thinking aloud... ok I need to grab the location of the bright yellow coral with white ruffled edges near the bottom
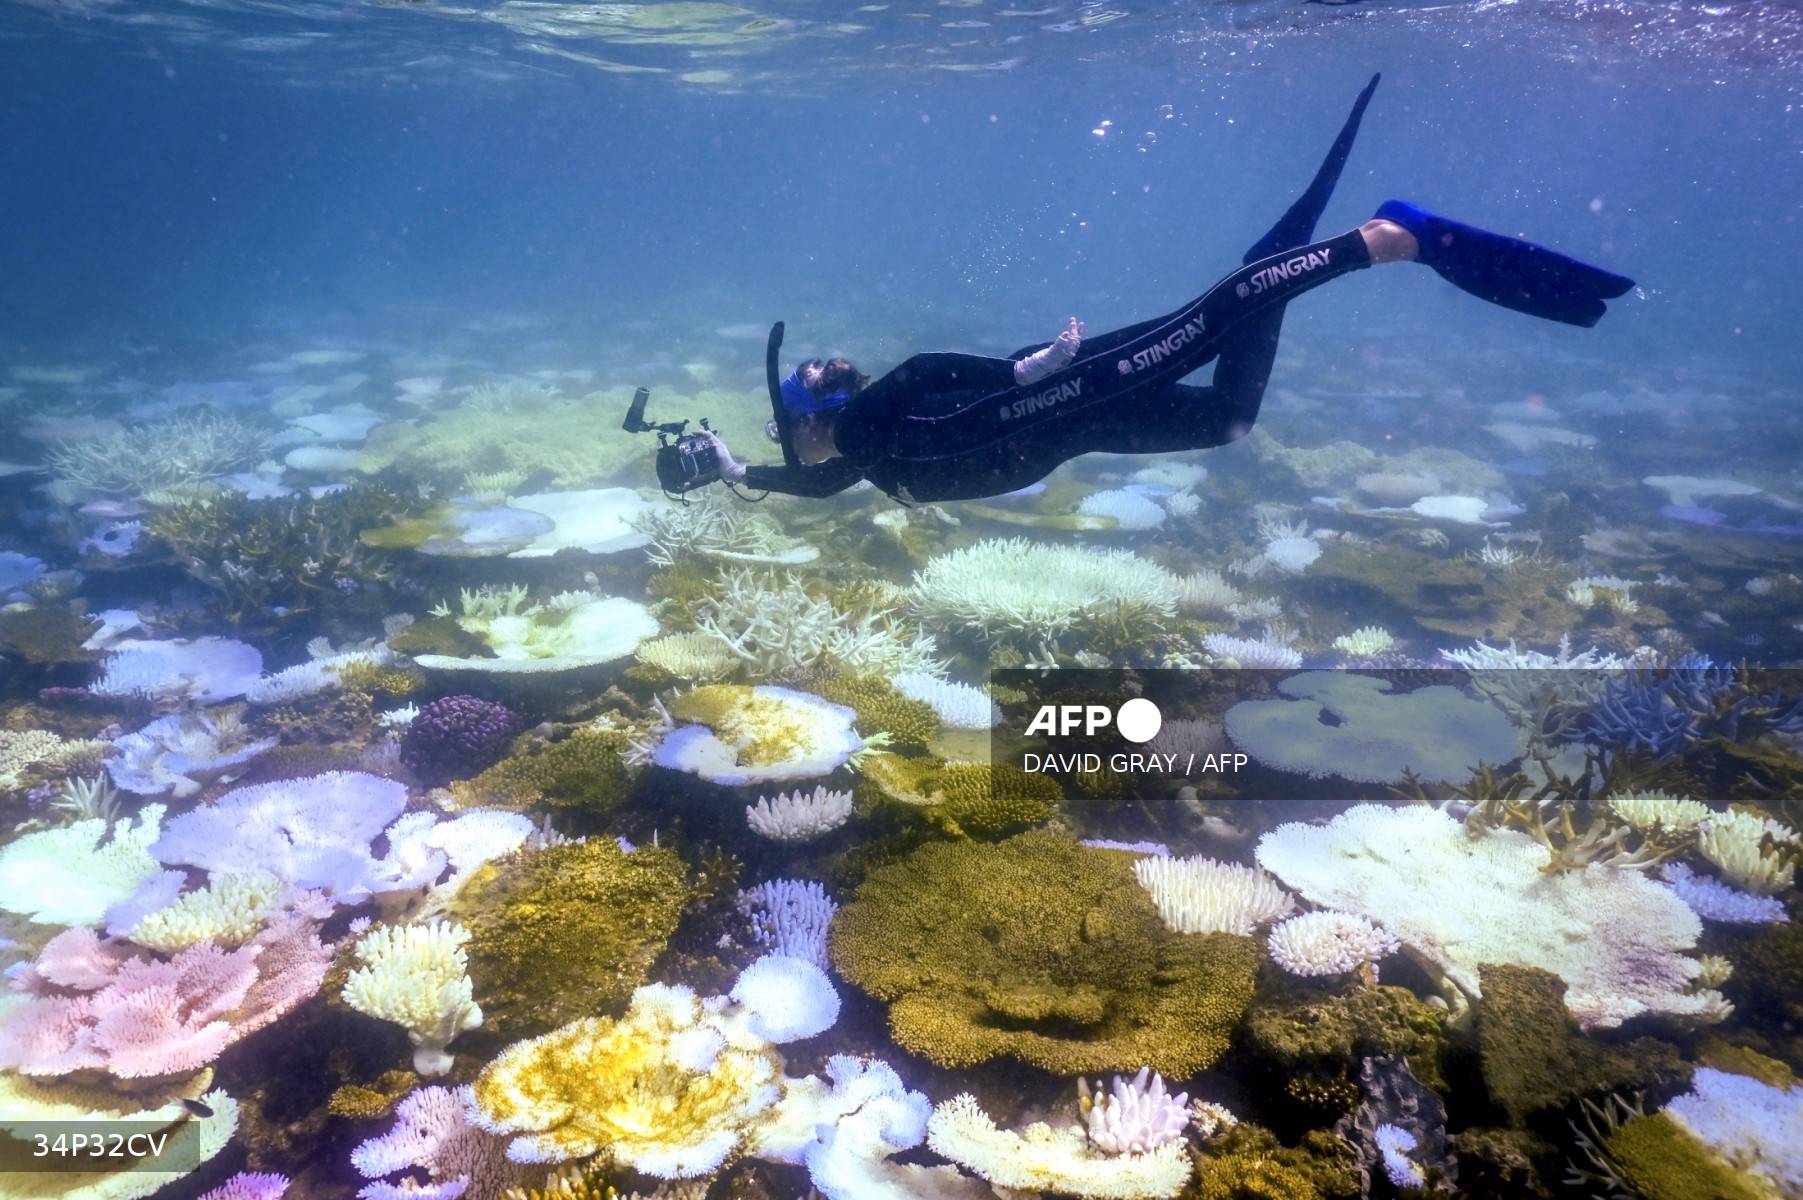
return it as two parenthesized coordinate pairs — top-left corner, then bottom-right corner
(472, 986), (783, 1177)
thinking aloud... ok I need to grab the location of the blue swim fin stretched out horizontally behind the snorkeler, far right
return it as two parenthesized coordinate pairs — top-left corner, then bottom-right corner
(1377, 200), (1634, 326)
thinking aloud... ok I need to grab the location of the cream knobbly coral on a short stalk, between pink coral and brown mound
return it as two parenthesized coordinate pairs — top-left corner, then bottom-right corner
(344, 921), (481, 1076)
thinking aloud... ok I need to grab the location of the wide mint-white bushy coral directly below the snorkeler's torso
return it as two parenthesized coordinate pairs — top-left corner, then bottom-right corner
(914, 537), (1177, 638)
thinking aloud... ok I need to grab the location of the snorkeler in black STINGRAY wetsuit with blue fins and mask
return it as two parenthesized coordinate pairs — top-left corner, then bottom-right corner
(709, 76), (1634, 503)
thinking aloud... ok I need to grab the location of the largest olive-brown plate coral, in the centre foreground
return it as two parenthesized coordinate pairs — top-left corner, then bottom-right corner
(829, 831), (1260, 1079)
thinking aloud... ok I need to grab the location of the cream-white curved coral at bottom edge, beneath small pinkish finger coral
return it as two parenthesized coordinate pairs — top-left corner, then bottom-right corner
(927, 1092), (1190, 1200)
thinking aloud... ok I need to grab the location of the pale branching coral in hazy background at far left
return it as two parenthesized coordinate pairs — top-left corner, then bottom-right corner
(50, 409), (269, 495)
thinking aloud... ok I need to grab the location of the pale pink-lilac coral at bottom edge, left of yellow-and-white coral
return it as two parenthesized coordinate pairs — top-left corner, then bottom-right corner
(350, 1086), (526, 1200)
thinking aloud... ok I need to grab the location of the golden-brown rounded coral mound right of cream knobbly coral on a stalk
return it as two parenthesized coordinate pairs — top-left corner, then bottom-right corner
(451, 838), (689, 1036)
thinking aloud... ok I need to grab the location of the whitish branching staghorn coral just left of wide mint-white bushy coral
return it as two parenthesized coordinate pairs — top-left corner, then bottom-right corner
(696, 568), (945, 676)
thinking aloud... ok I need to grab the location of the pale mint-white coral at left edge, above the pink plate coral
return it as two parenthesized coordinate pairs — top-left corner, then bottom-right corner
(0, 804), (164, 926)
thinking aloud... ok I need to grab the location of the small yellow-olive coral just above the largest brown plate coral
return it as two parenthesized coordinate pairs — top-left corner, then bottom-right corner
(860, 755), (1064, 838)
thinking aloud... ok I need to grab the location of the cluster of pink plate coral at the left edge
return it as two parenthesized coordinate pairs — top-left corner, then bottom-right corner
(0, 914), (332, 1079)
